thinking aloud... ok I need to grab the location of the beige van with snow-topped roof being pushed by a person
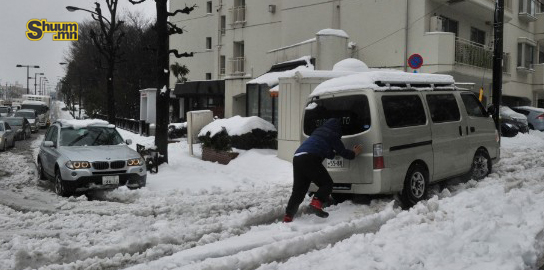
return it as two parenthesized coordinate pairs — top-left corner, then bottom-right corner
(302, 71), (500, 206)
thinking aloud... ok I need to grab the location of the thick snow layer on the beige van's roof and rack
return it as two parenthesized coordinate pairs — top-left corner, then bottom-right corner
(310, 70), (457, 97)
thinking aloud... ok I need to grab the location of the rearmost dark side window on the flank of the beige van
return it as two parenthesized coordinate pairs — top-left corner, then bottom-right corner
(382, 95), (427, 128)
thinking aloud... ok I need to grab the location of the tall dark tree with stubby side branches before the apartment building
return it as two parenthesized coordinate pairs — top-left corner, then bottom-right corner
(129, 0), (197, 162)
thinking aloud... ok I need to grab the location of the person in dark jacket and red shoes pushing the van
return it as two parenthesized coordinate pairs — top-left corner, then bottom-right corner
(283, 118), (363, 223)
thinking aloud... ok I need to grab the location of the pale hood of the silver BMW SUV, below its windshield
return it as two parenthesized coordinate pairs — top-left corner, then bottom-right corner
(58, 145), (140, 162)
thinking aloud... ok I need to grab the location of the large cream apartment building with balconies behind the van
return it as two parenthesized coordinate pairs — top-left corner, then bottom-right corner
(170, 0), (544, 118)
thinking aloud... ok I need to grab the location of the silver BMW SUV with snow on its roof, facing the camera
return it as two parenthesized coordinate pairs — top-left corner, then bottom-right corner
(37, 120), (147, 196)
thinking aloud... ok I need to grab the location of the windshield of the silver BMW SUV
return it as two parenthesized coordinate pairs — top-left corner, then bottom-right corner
(60, 126), (123, 146)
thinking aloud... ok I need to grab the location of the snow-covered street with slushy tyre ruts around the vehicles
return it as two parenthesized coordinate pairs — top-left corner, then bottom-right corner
(0, 103), (544, 270)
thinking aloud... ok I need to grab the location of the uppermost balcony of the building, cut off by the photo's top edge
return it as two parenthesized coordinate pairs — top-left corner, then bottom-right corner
(433, 0), (512, 22)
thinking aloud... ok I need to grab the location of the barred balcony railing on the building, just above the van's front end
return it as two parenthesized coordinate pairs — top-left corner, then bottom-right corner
(455, 38), (510, 73)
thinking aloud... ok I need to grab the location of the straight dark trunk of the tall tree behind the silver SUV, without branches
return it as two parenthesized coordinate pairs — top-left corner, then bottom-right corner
(155, 0), (170, 162)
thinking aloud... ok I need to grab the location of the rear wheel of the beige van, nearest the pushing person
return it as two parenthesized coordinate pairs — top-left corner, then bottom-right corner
(401, 164), (429, 207)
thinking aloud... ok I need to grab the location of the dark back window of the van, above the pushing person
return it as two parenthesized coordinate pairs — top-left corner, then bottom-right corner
(304, 95), (370, 135)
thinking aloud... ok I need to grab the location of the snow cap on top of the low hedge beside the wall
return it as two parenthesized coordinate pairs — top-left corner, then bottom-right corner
(198, 115), (276, 137)
